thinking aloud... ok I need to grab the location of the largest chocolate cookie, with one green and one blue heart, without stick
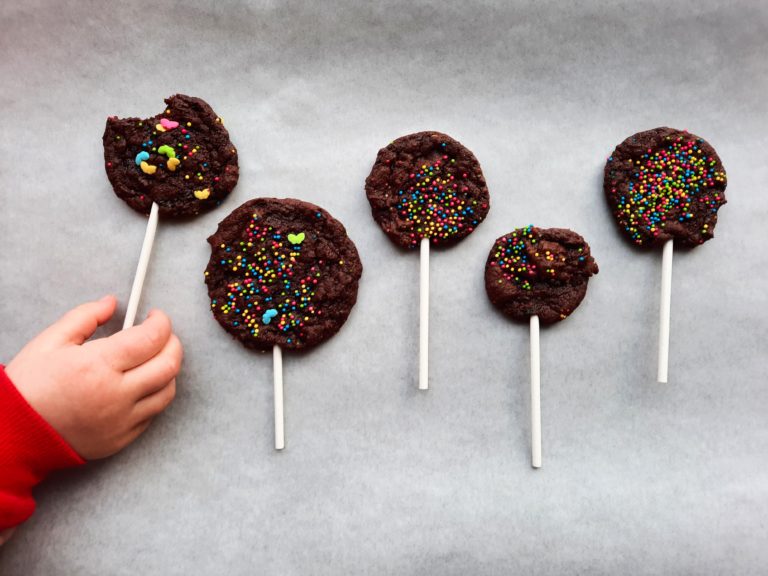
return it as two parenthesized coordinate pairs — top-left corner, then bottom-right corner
(205, 198), (363, 350)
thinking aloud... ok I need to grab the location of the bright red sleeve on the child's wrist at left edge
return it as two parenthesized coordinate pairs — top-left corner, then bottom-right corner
(0, 365), (85, 530)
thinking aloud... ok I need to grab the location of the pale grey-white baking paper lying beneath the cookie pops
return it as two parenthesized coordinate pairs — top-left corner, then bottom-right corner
(0, 0), (768, 576)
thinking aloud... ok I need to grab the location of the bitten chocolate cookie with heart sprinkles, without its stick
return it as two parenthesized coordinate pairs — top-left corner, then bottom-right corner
(104, 94), (238, 216)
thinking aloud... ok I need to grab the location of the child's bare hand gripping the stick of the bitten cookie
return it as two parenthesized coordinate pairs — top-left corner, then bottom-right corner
(5, 296), (182, 460)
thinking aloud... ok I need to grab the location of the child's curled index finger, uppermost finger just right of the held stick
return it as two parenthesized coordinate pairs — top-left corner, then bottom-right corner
(94, 310), (171, 371)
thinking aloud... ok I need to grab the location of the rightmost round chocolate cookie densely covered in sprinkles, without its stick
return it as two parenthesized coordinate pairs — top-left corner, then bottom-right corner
(603, 128), (727, 247)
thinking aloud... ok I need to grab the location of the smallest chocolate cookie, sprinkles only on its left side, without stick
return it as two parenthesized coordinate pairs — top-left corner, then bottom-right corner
(485, 226), (598, 324)
